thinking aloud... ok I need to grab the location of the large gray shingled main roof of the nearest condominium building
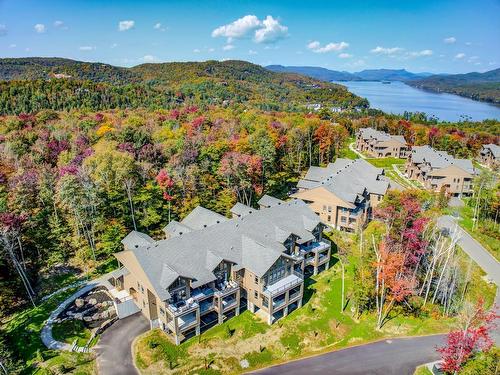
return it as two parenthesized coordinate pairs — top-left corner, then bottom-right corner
(120, 200), (324, 300)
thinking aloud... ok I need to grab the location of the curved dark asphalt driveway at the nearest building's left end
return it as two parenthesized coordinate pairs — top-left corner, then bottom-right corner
(95, 313), (149, 375)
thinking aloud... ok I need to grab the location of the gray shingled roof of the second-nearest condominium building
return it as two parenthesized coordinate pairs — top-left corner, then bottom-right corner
(297, 158), (389, 204)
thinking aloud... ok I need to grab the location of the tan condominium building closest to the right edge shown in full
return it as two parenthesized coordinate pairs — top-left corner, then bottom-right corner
(406, 146), (476, 196)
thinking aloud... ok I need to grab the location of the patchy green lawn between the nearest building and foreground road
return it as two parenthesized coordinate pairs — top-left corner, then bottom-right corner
(134, 232), (495, 374)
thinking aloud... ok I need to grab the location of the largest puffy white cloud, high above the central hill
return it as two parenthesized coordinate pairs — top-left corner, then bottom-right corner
(212, 14), (288, 43)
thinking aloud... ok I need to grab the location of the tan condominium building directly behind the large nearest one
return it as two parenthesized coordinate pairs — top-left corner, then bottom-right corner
(292, 158), (401, 232)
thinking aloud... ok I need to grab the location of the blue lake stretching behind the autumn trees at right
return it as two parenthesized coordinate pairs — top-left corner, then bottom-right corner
(336, 81), (500, 121)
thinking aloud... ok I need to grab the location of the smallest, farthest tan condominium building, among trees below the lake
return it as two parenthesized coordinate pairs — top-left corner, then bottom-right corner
(356, 128), (409, 158)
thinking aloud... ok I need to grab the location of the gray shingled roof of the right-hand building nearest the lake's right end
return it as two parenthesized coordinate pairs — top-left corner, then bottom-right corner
(411, 145), (475, 174)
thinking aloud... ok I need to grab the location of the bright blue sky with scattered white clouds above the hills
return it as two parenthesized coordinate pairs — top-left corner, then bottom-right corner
(0, 0), (500, 73)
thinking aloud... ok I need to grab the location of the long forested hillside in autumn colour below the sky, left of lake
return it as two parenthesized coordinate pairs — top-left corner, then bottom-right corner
(0, 58), (368, 114)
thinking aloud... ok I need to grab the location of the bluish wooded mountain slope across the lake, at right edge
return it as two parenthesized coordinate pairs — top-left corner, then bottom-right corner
(406, 69), (500, 104)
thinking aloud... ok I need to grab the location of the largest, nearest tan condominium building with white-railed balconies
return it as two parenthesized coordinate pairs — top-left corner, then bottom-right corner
(110, 196), (331, 344)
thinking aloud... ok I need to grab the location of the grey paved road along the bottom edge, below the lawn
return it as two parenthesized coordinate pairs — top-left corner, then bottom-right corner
(255, 335), (444, 375)
